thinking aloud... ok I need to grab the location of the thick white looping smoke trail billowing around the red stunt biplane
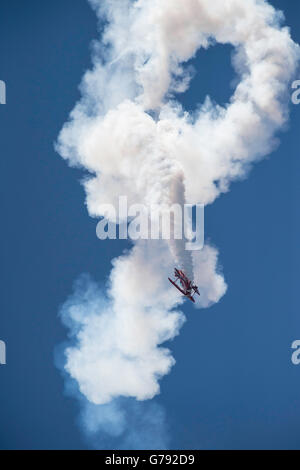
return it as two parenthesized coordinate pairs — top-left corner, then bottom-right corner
(57, 0), (299, 447)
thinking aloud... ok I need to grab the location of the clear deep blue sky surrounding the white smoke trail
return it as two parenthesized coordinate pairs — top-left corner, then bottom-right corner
(0, 0), (300, 449)
